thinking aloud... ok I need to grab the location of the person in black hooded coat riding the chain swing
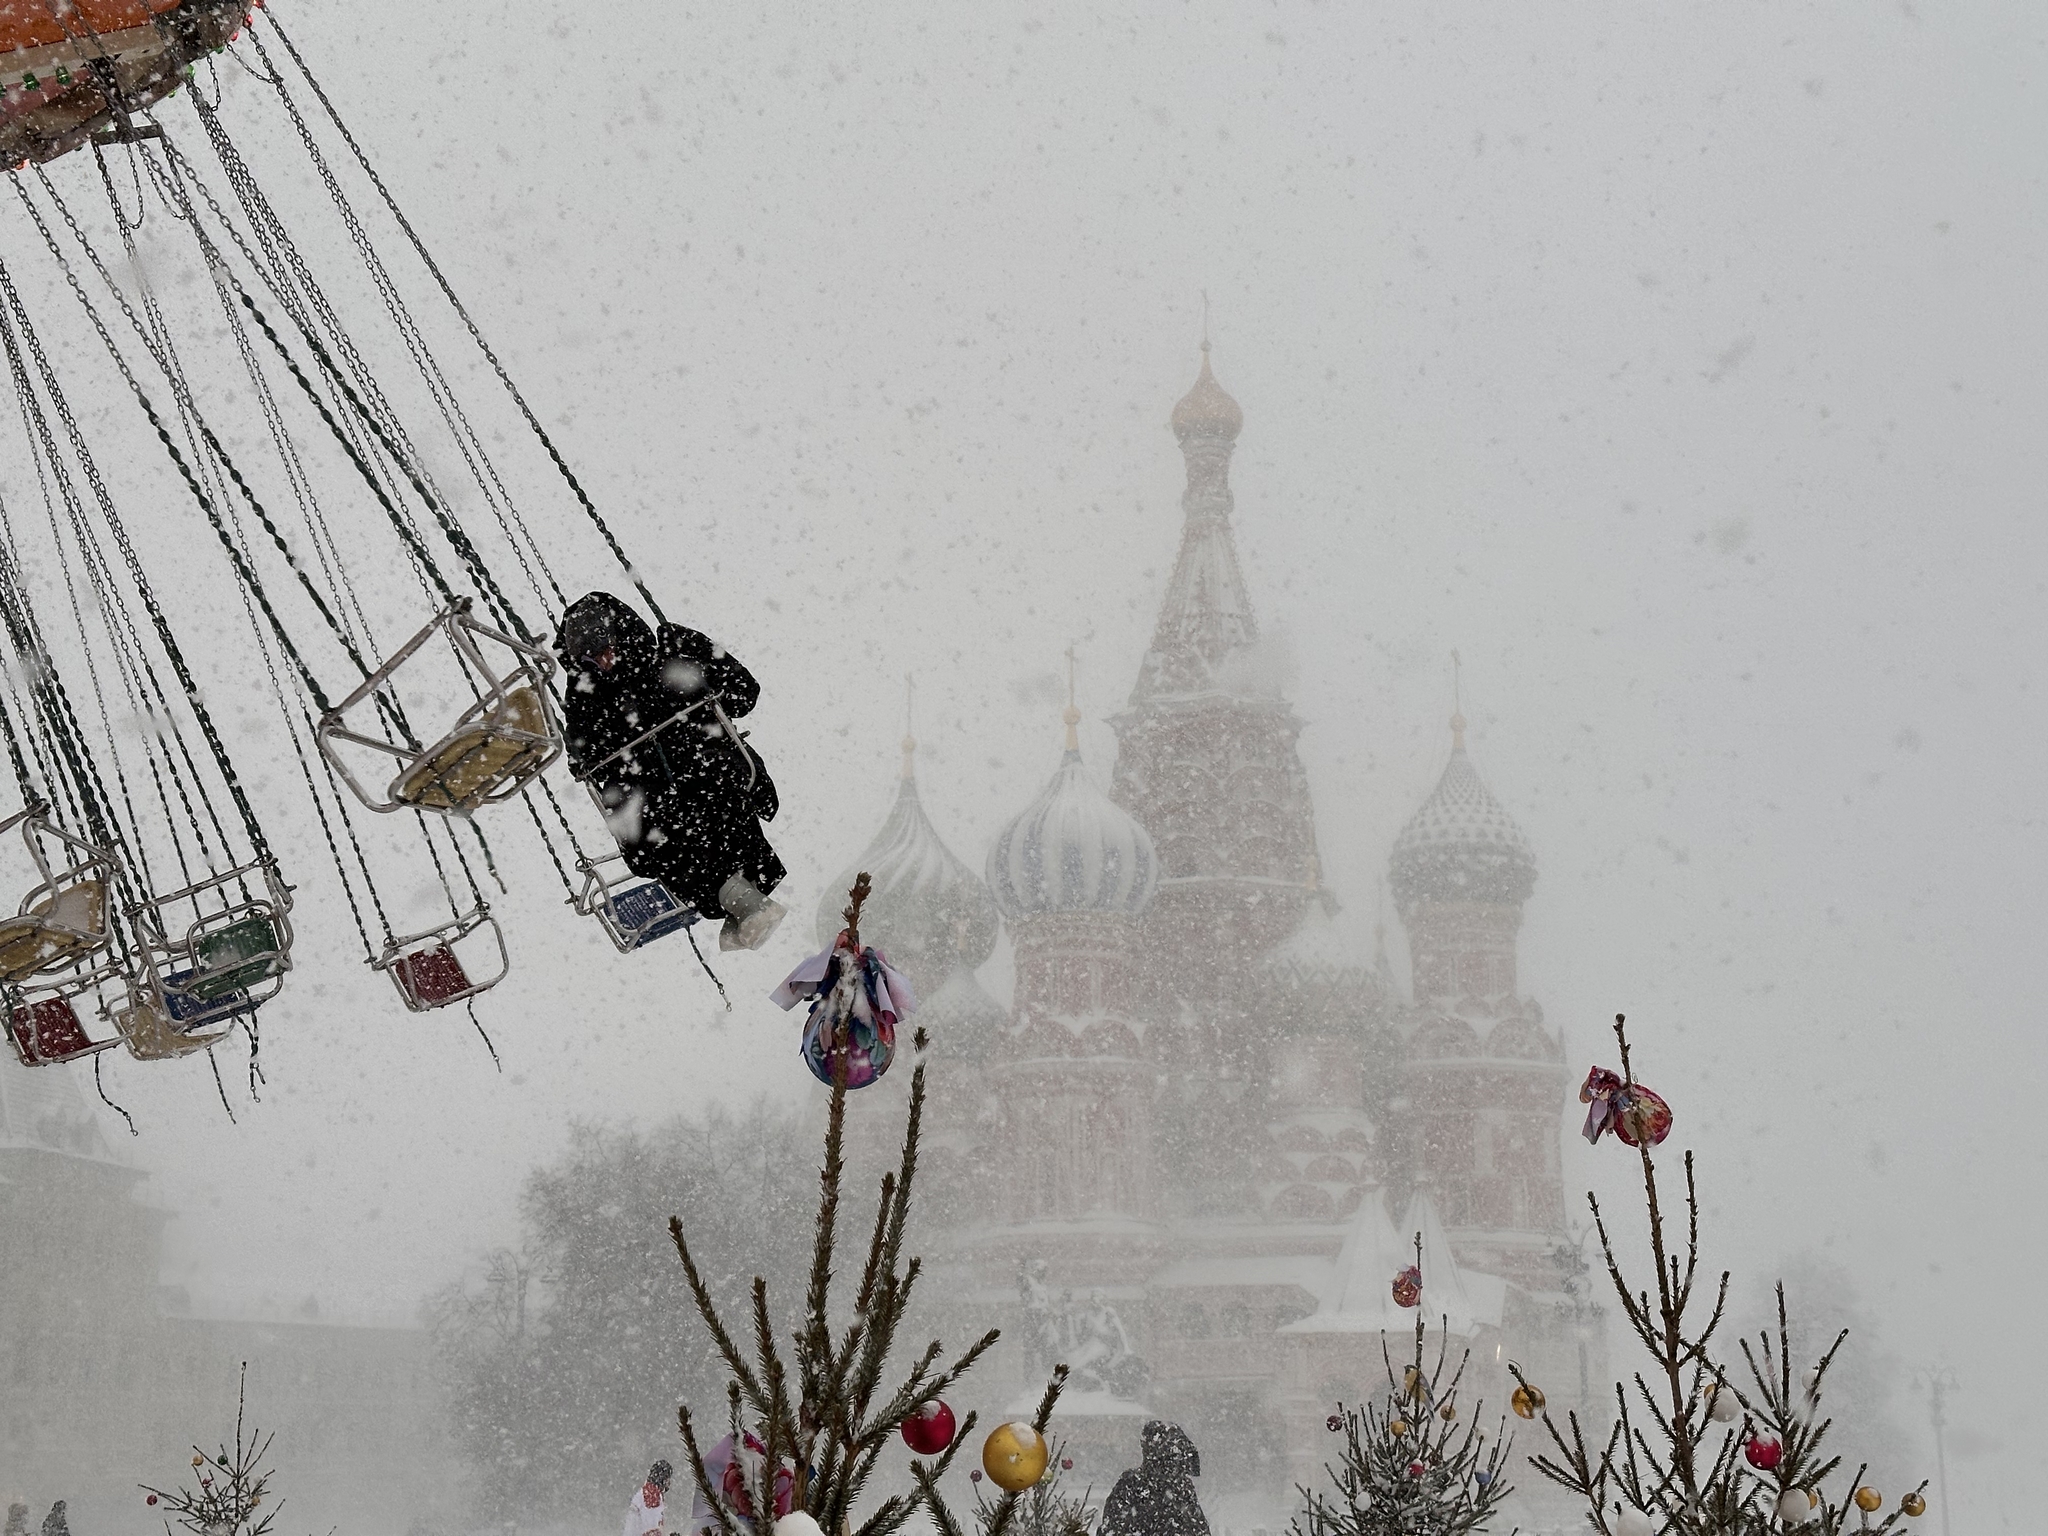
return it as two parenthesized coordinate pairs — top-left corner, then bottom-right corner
(559, 592), (784, 948)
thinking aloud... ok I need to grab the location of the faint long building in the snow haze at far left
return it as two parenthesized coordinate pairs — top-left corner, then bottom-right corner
(0, 1063), (457, 1534)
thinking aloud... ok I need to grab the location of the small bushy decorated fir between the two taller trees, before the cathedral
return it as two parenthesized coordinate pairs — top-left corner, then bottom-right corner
(1290, 1233), (1513, 1536)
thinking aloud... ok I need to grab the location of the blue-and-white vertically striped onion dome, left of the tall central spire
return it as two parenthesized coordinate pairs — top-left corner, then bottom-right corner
(987, 707), (1159, 920)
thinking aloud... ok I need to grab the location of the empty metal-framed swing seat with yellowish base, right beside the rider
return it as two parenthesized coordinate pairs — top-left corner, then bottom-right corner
(313, 598), (561, 817)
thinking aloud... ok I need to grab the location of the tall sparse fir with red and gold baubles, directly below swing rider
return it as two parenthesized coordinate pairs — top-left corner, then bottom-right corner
(670, 872), (1067, 1536)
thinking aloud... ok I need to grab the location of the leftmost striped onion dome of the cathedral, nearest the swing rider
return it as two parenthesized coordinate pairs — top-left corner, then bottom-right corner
(817, 737), (995, 989)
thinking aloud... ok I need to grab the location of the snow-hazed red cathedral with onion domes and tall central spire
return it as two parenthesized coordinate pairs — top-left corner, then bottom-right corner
(817, 352), (1591, 1526)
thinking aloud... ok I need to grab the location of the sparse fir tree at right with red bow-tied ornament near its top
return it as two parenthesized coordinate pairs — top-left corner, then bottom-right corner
(1507, 1014), (1927, 1536)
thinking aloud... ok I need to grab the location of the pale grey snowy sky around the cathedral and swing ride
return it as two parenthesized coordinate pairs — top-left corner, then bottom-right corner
(8, 0), (2048, 1532)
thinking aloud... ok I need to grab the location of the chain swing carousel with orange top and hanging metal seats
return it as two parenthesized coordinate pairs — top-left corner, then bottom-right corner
(0, 0), (780, 1097)
